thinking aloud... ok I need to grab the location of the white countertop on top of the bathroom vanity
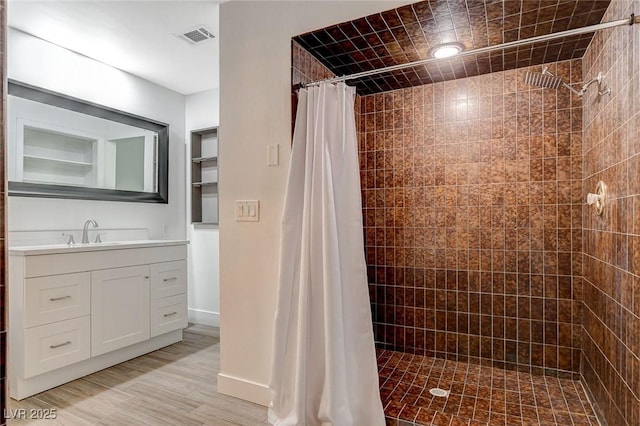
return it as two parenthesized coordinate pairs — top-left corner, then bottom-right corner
(9, 240), (189, 256)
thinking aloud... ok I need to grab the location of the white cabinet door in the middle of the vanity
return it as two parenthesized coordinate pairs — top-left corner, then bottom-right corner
(91, 266), (149, 356)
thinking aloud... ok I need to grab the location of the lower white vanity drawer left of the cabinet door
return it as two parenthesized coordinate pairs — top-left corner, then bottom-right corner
(24, 316), (91, 378)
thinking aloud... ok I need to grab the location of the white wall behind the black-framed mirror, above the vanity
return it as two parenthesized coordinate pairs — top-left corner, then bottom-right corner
(7, 29), (186, 239)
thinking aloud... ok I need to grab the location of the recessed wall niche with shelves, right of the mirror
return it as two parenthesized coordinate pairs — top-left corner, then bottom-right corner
(191, 127), (218, 225)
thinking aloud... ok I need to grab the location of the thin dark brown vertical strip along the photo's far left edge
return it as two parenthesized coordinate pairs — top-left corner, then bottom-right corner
(0, 0), (8, 425)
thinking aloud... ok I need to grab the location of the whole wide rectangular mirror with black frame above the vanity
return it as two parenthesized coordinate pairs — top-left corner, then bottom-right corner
(7, 80), (169, 203)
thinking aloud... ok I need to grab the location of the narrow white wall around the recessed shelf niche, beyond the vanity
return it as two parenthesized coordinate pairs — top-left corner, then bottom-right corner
(185, 89), (224, 326)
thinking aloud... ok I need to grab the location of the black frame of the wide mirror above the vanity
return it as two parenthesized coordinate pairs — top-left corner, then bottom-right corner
(7, 79), (169, 204)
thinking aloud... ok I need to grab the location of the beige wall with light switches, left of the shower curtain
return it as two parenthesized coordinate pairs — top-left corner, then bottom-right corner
(218, 1), (410, 405)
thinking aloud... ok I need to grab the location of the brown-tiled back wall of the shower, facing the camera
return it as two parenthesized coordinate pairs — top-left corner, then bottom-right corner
(360, 60), (582, 374)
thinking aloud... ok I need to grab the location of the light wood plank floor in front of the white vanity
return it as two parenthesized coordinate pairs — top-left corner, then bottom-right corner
(9, 325), (268, 426)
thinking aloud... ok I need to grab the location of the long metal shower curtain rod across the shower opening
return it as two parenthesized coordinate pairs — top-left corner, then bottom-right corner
(301, 13), (640, 87)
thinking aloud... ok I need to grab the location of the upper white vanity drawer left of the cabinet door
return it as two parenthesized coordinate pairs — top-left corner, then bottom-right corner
(24, 272), (91, 328)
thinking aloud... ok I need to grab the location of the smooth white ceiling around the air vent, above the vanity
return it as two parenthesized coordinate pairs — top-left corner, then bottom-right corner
(8, 0), (219, 95)
